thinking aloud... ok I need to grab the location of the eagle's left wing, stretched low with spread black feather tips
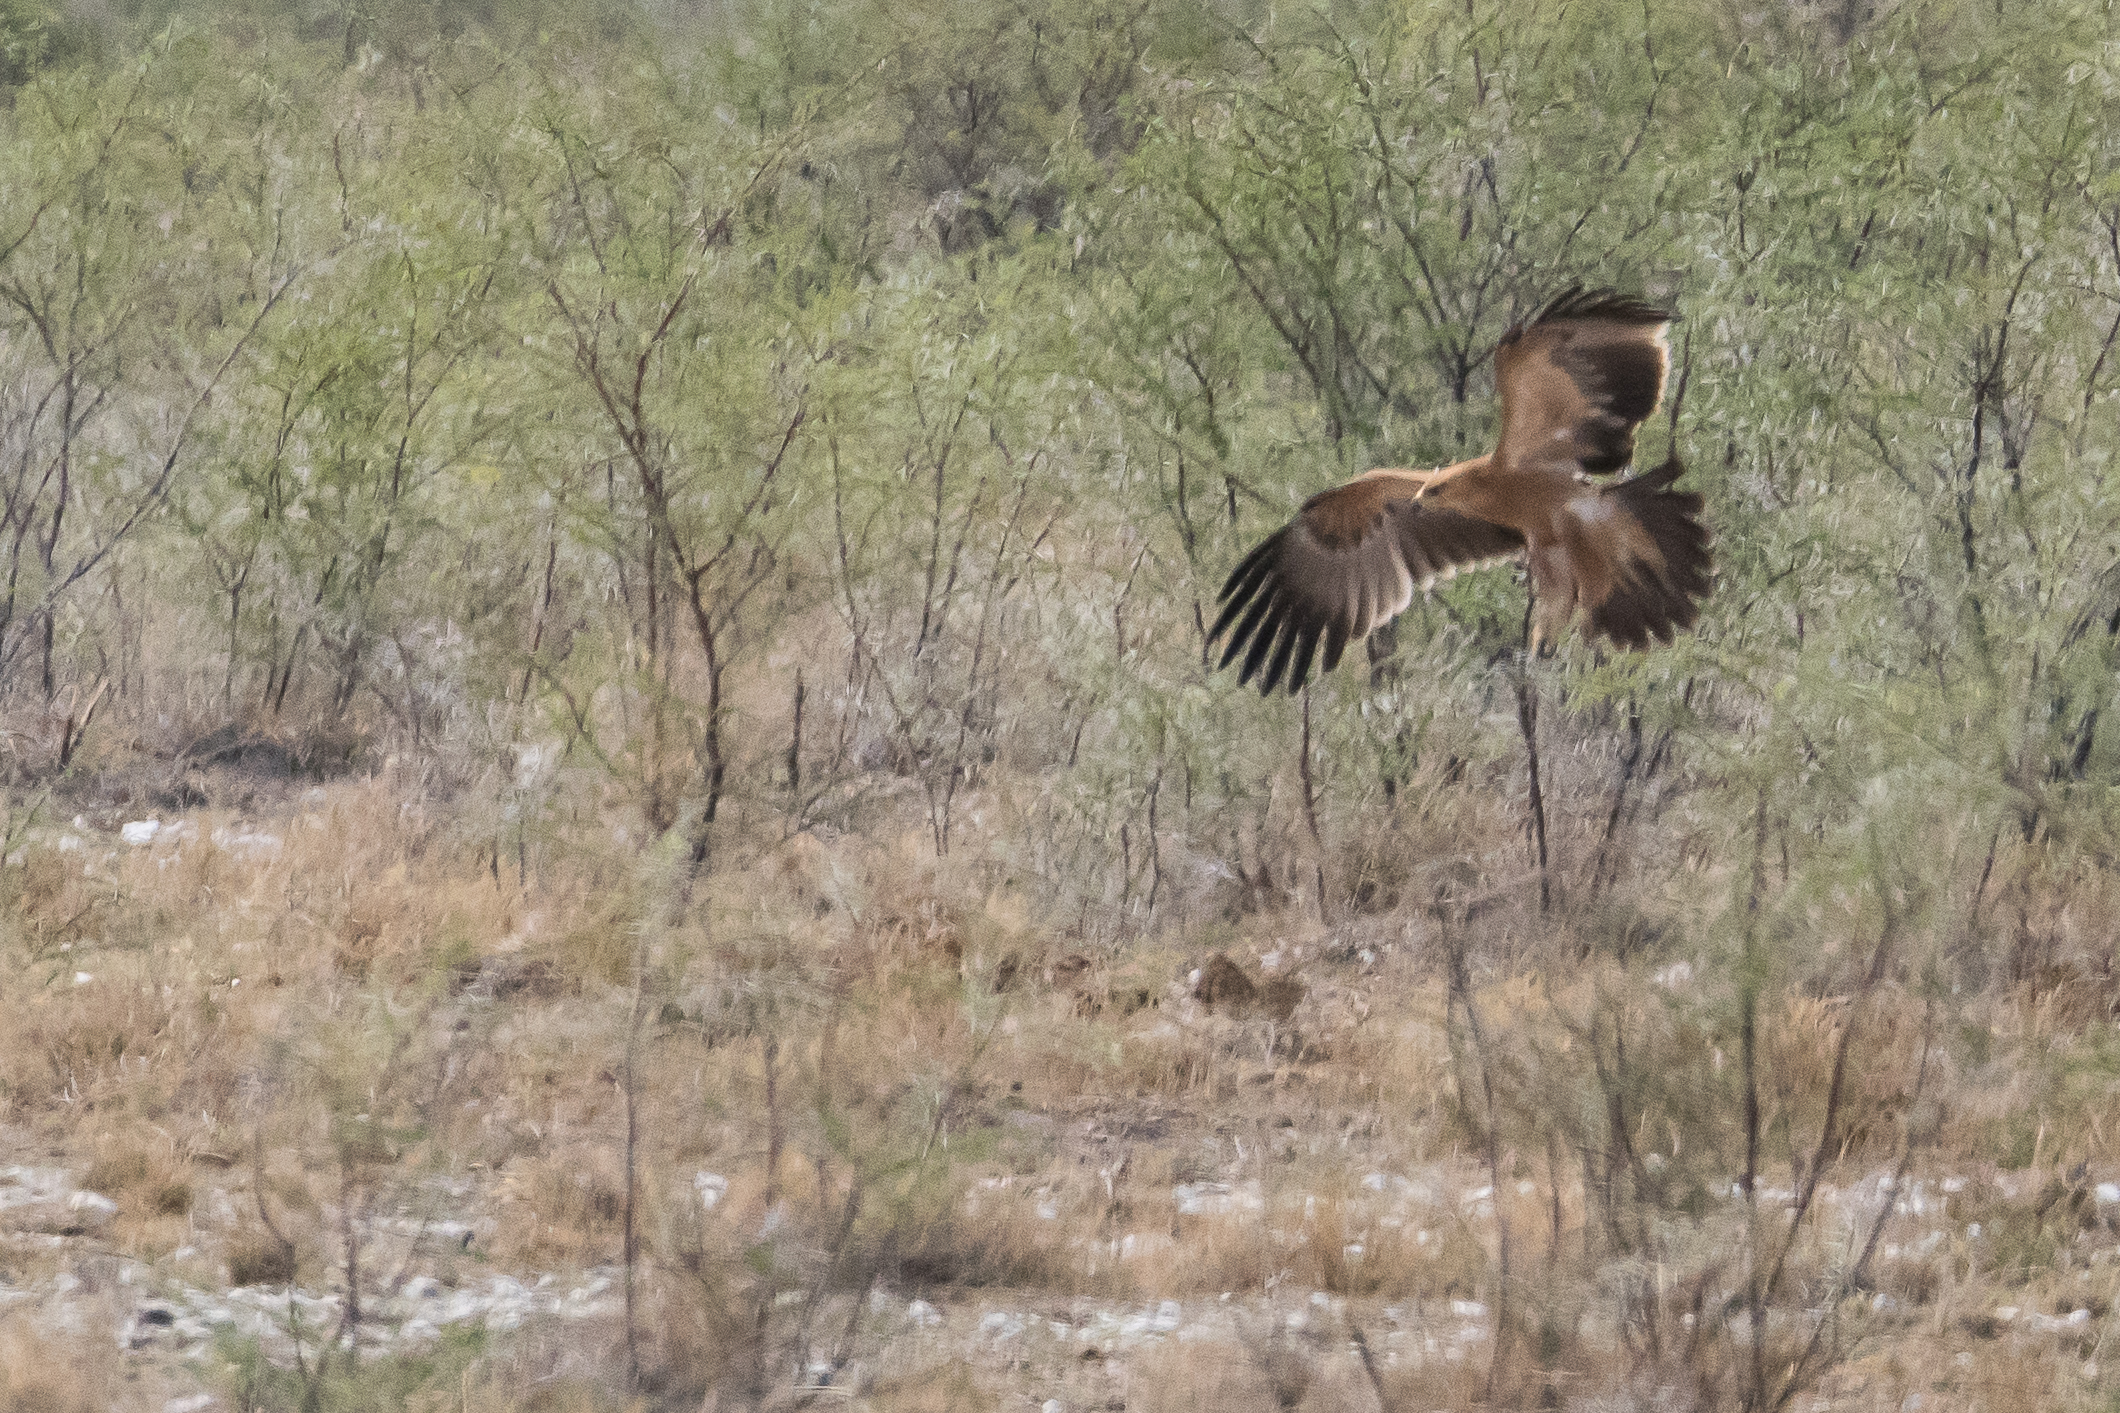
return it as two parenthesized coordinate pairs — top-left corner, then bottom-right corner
(1206, 470), (1524, 695)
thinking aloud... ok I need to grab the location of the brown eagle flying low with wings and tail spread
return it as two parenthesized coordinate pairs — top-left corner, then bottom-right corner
(1208, 288), (1715, 693)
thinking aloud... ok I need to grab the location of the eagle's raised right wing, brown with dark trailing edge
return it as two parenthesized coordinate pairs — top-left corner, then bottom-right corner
(1495, 288), (1677, 475)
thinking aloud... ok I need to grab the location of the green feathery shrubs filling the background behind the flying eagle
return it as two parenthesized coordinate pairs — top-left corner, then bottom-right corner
(16, 0), (2120, 1392)
